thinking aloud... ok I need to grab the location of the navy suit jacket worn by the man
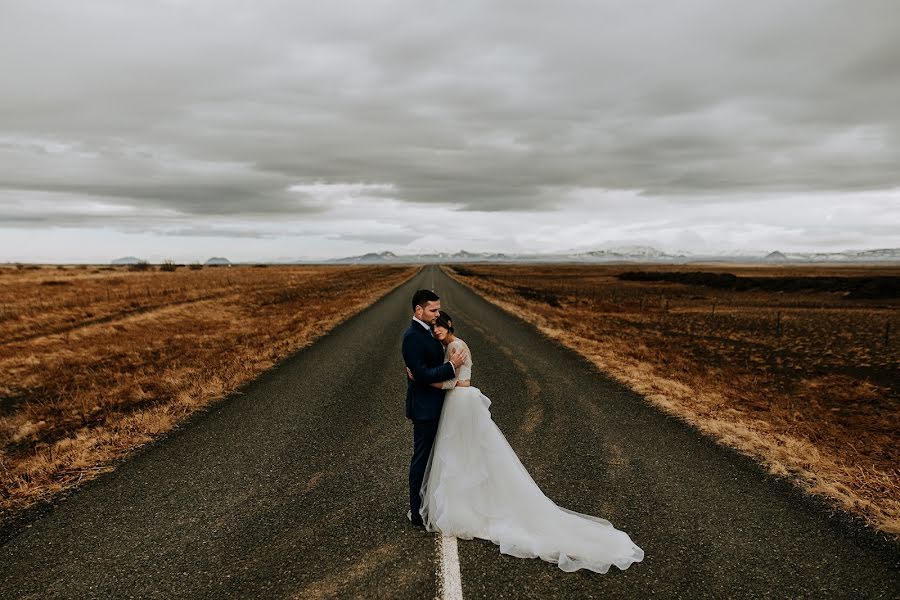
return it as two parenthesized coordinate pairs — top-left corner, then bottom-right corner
(402, 321), (454, 421)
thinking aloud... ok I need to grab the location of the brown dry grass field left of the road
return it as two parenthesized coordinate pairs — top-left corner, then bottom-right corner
(0, 265), (416, 522)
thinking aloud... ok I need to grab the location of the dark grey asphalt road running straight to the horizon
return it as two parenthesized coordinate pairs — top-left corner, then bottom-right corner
(0, 267), (900, 599)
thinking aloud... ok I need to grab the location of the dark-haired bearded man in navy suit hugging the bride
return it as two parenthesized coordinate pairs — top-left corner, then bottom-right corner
(402, 290), (466, 527)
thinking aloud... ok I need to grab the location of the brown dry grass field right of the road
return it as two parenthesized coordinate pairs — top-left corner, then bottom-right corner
(447, 265), (900, 536)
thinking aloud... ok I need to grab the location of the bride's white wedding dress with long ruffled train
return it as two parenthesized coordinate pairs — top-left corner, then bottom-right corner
(420, 338), (644, 573)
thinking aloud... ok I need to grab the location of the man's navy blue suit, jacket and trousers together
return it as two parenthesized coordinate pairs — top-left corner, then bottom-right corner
(402, 320), (454, 519)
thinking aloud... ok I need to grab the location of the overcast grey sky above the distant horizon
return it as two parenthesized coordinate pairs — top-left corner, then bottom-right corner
(0, 0), (900, 262)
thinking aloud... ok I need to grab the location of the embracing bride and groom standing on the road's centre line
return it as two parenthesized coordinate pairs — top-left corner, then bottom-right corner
(402, 290), (644, 573)
